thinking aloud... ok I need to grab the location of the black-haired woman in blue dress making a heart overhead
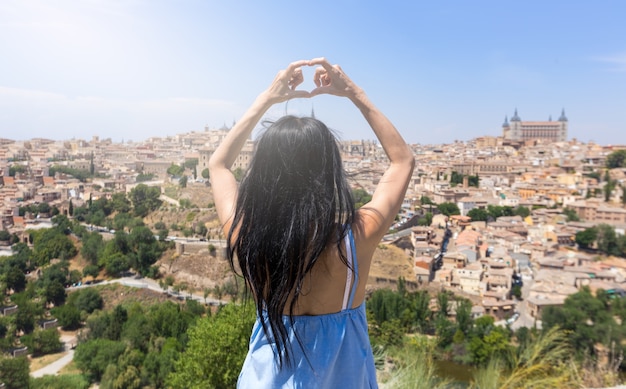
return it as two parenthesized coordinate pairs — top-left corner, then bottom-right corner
(209, 58), (414, 388)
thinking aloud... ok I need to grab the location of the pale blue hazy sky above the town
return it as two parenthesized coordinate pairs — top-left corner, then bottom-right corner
(0, 0), (626, 144)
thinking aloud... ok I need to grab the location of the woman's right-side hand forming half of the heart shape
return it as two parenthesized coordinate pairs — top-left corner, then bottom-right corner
(308, 58), (360, 98)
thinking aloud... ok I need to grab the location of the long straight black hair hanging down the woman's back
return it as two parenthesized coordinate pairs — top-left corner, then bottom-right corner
(228, 116), (355, 368)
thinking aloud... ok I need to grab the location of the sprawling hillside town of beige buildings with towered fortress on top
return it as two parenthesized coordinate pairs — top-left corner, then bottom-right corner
(0, 110), (626, 327)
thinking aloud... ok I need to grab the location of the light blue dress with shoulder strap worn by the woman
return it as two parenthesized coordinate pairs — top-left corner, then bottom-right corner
(237, 231), (378, 389)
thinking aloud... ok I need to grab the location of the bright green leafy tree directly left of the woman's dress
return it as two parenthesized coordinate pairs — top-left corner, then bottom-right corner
(167, 304), (255, 389)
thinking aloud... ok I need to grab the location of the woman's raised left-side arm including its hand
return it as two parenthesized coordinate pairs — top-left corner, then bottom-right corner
(209, 61), (310, 232)
